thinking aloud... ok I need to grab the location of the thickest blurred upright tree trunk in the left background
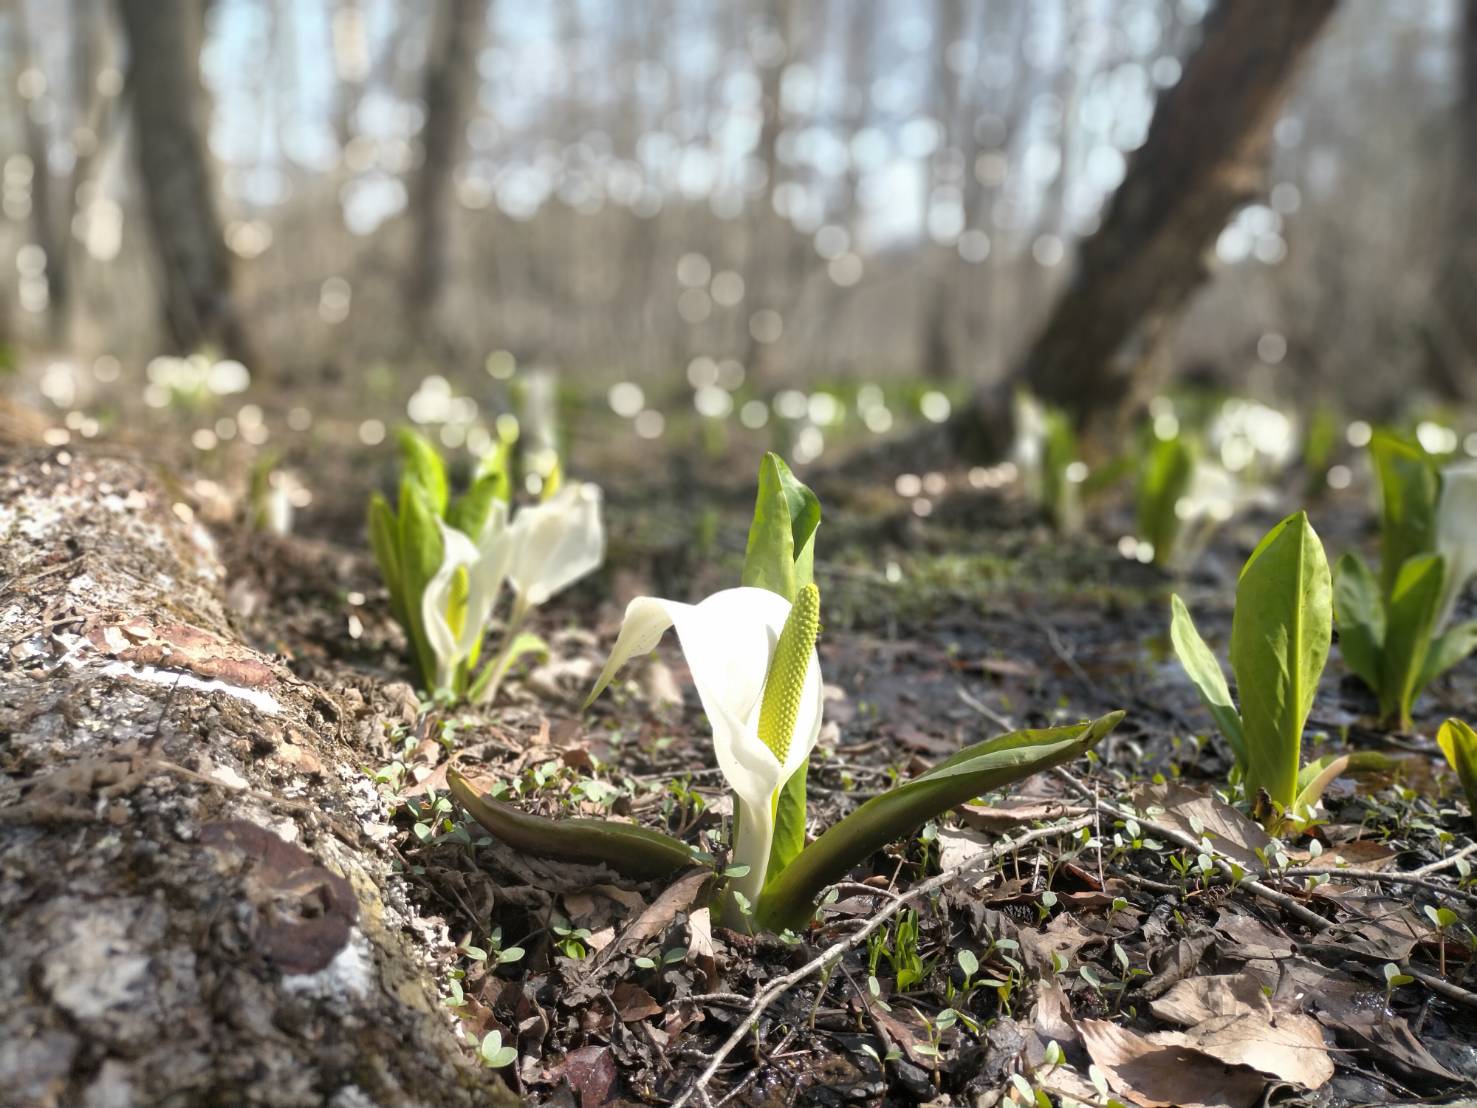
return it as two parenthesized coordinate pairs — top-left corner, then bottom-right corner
(118, 0), (256, 365)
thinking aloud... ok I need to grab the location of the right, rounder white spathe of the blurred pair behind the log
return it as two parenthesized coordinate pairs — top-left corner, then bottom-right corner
(508, 482), (606, 606)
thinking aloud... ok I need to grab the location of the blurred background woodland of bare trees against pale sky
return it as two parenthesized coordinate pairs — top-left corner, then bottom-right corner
(0, 0), (1477, 445)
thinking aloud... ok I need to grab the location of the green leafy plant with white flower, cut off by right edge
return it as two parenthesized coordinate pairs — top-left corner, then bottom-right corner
(1334, 431), (1477, 730)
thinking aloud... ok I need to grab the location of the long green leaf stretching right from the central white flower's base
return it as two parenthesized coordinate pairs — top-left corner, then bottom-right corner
(756, 712), (1124, 931)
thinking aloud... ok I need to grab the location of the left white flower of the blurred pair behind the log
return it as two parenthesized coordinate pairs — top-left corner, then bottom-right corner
(421, 501), (513, 688)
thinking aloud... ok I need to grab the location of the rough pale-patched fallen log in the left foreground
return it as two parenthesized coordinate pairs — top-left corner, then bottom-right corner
(0, 451), (517, 1108)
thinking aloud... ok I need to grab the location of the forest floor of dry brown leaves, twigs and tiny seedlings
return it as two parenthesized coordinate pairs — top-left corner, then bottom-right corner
(8, 384), (1477, 1108)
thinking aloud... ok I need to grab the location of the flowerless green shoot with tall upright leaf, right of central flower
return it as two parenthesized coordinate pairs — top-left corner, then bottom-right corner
(1170, 511), (1347, 824)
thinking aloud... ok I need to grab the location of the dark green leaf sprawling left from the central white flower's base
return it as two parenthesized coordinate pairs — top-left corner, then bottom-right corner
(446, 770), (702, 879)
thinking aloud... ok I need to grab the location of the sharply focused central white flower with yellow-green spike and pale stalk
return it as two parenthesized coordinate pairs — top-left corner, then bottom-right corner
(586, 585), (823, 906)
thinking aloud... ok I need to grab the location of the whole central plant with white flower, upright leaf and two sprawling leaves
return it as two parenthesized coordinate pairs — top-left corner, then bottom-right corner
(448, 455), (1123, 932)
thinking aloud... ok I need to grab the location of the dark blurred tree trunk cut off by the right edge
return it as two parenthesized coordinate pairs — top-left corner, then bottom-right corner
(1425, 0), (1477, 403)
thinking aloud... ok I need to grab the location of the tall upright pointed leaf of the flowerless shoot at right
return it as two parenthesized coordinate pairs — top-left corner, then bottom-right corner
(1230, 511), (1334, 811)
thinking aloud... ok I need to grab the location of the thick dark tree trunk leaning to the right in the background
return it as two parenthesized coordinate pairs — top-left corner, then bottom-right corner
(956, 0), (1337, 454)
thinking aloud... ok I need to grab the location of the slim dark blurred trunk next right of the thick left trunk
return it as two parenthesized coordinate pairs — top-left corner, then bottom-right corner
(406, 0), (487, 338)
